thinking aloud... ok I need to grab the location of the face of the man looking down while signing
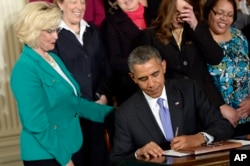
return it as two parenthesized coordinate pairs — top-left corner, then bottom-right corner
(130, 58), (166, 98)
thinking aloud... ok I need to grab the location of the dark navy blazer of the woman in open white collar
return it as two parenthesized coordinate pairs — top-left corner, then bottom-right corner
(53, 24), (111, 100)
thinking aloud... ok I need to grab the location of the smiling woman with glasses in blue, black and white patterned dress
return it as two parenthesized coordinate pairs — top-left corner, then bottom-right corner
(204, 0), (250, 136)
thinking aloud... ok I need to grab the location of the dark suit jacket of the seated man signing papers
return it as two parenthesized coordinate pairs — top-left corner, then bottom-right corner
(110, 80), (233, 166)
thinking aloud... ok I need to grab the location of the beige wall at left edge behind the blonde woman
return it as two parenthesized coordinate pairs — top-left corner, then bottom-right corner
(0, 0), (27, 166)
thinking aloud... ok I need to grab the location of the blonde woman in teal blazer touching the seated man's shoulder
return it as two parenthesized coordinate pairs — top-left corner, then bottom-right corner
(11, 2), (113, 166)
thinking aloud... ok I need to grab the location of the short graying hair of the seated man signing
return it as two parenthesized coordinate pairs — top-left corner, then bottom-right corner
(128, 45), (162, 72)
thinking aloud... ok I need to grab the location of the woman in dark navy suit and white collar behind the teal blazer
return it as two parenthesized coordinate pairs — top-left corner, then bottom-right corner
(53, 0), (110, 166)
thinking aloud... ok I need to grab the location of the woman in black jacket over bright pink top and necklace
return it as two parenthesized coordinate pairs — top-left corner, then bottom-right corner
(102, 0), (156, 105)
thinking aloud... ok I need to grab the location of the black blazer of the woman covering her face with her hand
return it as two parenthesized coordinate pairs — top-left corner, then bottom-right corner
(141, 23), (224, 106)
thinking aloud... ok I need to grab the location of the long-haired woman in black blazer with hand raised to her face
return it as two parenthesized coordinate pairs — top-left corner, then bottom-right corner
(141, 0), (224, 107)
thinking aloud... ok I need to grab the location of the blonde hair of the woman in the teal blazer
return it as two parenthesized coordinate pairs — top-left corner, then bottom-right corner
(14, 1), (62, 48)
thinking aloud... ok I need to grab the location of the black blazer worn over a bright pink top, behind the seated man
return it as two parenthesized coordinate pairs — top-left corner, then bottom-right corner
(102, 8), (154, 104)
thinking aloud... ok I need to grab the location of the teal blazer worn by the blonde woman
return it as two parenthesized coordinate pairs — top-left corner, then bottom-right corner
(10, 45), (113, 165)
